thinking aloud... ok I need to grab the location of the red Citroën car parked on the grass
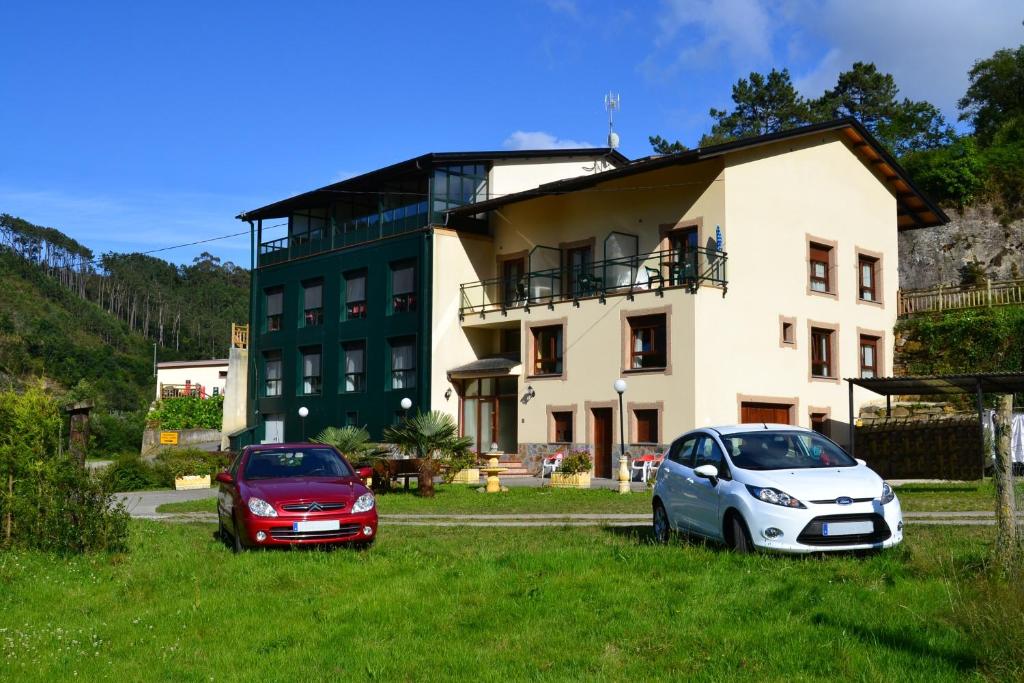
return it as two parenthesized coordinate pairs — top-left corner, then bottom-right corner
(217, 443), (377, 552)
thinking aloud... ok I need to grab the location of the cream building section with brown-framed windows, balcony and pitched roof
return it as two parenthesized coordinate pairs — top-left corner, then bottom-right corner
(430, 121), (946, 476)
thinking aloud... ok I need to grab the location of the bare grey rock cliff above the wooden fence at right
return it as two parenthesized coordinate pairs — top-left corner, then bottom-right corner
(899, 206), (1024, 290)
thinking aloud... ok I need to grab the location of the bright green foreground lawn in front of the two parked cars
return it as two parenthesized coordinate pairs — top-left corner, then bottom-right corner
(0, 520), (1017, 681)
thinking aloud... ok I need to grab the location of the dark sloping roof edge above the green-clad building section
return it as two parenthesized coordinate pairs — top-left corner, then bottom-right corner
(236, 147), (630, 221)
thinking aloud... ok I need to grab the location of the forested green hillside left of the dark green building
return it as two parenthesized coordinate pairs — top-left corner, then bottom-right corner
(0, 214), (249, 455)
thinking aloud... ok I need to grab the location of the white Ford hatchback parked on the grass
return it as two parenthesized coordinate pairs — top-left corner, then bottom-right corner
(653, 424), (903, 553)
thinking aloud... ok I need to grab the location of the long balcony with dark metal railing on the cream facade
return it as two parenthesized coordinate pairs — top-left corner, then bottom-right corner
(459, 247), (728, 319)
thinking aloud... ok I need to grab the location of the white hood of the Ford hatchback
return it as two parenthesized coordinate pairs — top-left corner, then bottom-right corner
(736, 465), (882, 502)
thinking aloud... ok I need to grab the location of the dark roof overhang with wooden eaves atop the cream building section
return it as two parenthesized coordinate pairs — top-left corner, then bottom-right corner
(449, 118), (949, 229)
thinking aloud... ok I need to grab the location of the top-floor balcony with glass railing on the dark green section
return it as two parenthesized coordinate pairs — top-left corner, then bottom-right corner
(259, 200), (429, 267)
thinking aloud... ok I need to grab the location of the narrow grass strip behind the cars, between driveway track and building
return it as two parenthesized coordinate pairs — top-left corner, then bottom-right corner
(151, 479), (1024, 514)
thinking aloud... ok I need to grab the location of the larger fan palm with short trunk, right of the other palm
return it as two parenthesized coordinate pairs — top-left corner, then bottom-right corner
(384, 411), (473, 498)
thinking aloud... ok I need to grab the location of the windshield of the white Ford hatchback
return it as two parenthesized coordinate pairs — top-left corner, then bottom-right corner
(722, 431), (857, 470)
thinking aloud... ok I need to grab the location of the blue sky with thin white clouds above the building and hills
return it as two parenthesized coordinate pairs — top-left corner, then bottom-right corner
(0, 0), (1024, 265)
